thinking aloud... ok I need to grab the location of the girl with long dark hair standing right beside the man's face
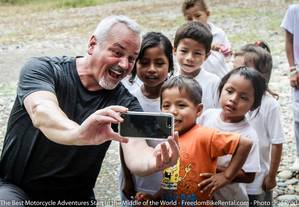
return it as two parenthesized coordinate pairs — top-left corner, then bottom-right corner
(122, 32), (173, 206)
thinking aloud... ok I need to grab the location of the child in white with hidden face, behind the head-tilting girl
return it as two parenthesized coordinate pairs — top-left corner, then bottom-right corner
(234, 41), (284, 206)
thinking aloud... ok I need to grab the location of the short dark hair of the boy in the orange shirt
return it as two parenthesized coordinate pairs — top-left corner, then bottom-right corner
(160, 75), (202, 104)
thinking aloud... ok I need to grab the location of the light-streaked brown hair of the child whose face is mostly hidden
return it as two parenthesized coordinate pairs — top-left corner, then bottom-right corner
(235, 41), (279, 99)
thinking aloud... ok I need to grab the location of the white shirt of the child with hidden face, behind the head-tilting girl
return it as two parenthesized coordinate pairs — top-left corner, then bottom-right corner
(246, 94), (284, 195)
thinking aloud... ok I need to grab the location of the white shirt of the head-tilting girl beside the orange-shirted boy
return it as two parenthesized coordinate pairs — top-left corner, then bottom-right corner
(199, 108), (260, 206)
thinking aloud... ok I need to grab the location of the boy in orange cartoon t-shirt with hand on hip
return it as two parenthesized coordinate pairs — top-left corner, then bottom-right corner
(160, 76), (252, 206)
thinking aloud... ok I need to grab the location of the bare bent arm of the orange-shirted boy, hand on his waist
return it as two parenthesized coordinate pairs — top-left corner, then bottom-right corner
(198, 138), (252, 195)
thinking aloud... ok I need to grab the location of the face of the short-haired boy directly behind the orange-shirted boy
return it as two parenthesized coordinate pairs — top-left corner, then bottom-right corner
(174, 38), (207, 77)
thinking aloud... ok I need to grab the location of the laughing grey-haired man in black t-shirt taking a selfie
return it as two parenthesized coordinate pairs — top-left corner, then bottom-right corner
(0, 16), (178, 206)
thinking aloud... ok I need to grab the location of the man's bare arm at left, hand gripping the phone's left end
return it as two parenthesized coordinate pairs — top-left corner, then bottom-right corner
(24, 91), (127, 145)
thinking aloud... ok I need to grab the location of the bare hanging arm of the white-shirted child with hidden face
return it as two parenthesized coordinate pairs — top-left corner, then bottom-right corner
(262, 144), (282, 191)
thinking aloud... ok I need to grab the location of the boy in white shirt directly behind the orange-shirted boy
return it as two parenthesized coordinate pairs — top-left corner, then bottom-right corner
(174, 22), (220, 110)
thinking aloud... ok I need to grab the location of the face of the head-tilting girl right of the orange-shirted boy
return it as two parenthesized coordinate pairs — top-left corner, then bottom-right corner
(219, 74), (254, 123)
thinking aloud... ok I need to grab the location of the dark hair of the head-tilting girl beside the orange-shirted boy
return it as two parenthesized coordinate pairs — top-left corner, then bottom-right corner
(218, 66), (267, 110)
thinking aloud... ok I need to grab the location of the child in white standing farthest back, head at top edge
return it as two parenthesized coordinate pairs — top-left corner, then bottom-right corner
(182, 0), (231, 78)
